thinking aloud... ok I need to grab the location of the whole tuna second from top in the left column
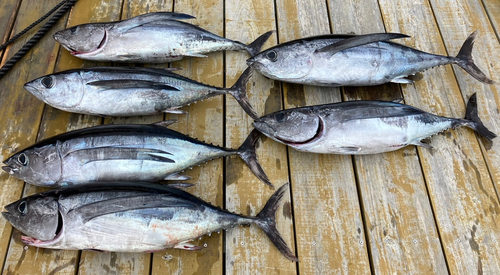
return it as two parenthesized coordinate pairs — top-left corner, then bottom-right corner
(24, 67), (258, 119)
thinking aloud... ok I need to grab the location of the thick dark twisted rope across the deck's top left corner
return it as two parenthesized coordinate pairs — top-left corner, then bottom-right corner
(0, 0), (78, 79)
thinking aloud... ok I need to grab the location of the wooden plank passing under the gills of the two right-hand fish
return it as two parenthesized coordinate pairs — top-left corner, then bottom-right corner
(276, 1), (370, 274)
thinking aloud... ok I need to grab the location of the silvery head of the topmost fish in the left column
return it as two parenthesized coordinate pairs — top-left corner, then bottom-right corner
(54, 23), (108, 56)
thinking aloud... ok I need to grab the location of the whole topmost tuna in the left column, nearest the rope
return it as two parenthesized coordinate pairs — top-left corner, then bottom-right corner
(54, 12), (272, 63)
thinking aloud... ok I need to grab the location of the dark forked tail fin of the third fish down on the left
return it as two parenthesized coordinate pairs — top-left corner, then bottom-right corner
(238, 129), (274, 187)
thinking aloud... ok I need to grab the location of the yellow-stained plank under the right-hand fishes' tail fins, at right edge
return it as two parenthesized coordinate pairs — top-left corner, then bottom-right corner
(431, 0), (500, 203)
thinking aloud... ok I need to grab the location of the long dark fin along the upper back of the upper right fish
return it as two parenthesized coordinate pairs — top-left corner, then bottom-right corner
(315, 33), (409, 55)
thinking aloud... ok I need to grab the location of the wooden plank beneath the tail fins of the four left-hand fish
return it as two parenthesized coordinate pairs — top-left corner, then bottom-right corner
(225, 0), (296, 274)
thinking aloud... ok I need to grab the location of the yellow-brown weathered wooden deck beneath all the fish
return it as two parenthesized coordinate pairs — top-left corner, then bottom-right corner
(0, 0), (500, 274)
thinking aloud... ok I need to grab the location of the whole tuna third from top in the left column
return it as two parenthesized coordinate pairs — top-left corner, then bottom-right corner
(2, 121), (272, 187)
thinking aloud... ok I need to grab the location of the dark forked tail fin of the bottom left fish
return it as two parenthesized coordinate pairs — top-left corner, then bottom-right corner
(255, 183), (299, 262)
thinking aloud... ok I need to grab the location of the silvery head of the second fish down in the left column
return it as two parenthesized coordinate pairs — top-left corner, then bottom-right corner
(24, 71), (85, 109)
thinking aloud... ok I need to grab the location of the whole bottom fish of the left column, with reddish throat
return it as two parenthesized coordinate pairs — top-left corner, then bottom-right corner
(2, 183), (298, 261)
